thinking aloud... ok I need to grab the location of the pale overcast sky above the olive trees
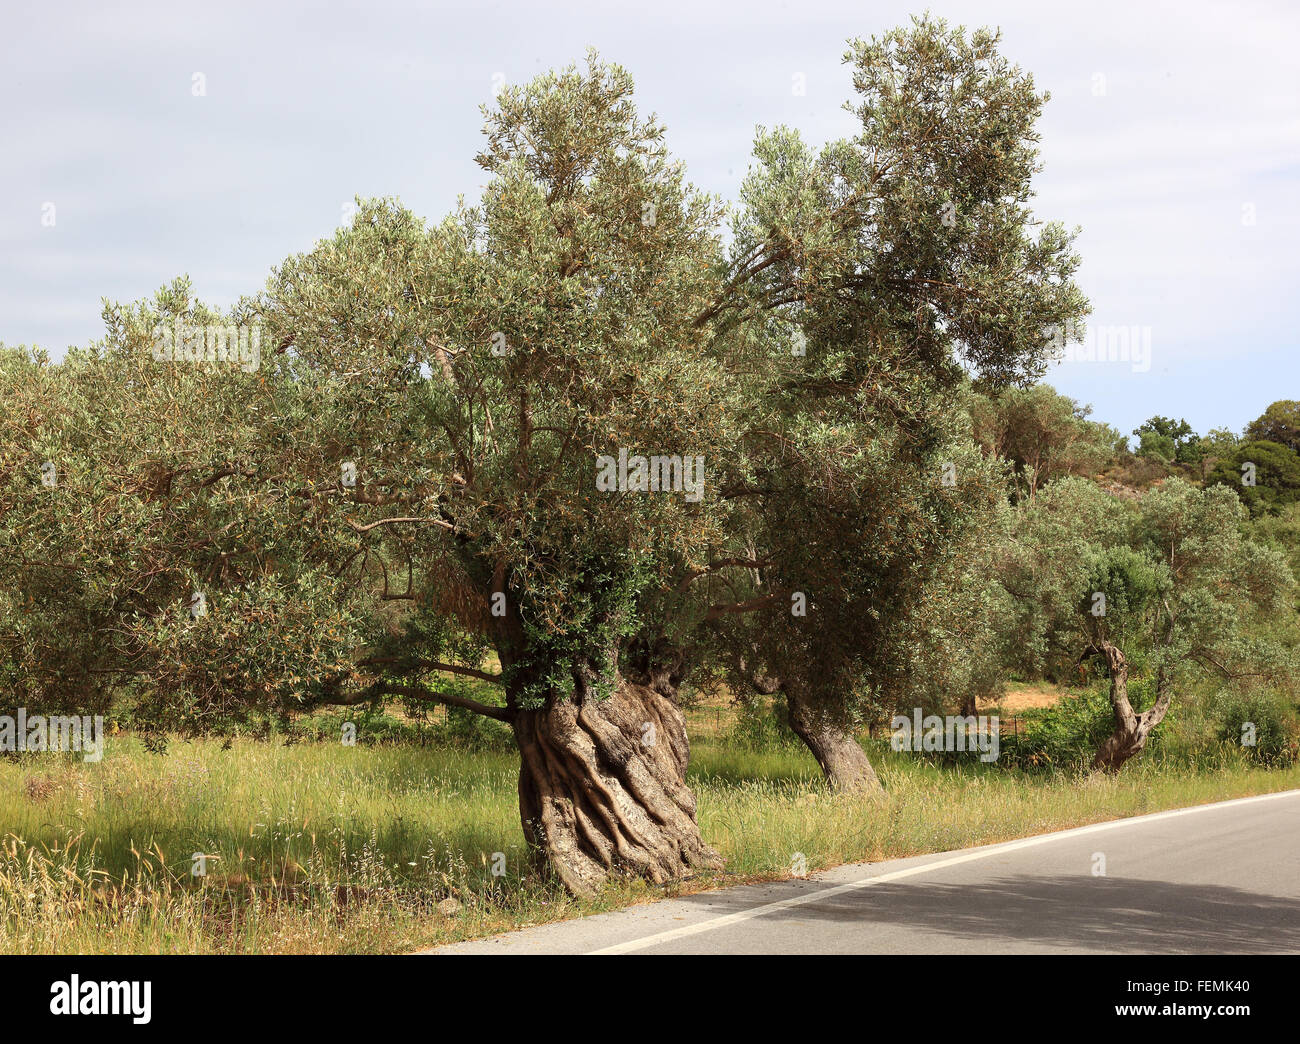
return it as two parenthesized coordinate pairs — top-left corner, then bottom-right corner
(0, 0), (1300, 432)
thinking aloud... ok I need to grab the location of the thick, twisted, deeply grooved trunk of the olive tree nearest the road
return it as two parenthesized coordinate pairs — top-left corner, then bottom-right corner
(512, 679), (722, 896)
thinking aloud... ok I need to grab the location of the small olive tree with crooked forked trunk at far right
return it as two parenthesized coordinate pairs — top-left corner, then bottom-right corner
(1001, 478), (1294, 772)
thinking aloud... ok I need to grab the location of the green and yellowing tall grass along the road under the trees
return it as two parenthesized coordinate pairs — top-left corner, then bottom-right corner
(0, 736), (1300, 953)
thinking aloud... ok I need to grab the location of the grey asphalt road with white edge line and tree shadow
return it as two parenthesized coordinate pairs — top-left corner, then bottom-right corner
(429, 790), (1300, 954)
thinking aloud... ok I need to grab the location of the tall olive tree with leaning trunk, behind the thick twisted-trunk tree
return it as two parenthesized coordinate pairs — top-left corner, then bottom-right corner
(691, 20), (1087, 789)
